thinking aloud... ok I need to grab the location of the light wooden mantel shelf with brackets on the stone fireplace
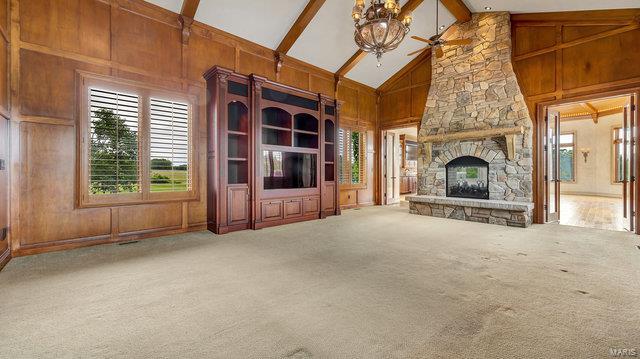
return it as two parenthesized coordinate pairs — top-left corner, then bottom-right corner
(421, 126), (524, 162)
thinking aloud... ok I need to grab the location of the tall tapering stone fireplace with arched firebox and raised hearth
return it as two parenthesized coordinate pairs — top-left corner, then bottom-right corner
(409, 12), (533, 227)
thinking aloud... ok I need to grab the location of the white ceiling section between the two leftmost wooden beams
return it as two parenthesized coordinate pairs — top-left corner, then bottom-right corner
(195, 0), (307, 49)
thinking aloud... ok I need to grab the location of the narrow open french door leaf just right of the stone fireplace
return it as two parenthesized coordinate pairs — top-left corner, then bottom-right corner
(544, 110), (560, 222)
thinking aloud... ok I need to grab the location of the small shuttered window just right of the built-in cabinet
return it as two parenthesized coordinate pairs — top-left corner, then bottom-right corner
(338, 128), (367, 187)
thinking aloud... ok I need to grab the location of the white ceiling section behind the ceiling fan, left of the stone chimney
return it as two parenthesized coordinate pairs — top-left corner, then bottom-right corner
(346, 0), (456, 88)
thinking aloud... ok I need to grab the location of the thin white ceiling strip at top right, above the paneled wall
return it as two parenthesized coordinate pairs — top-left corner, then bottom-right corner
(464, 0), (640, 14)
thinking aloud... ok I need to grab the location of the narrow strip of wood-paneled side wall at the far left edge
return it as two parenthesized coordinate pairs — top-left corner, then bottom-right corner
(0, 0), (11, 269)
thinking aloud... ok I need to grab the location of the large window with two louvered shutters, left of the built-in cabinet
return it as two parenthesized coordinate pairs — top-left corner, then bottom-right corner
(78, 75), (196, 206)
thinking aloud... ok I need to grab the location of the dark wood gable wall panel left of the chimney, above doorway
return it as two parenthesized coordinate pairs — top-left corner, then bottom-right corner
(378, 51), (431, 129)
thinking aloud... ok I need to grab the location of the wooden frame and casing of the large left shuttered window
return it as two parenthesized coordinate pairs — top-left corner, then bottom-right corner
(76, 71), (199, 208)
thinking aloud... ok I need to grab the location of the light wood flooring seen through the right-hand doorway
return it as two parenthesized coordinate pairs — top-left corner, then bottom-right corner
(560, 194), (627, 231)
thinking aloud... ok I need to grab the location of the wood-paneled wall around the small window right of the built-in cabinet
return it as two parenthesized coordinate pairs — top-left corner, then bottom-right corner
(337, 78), (380, 208)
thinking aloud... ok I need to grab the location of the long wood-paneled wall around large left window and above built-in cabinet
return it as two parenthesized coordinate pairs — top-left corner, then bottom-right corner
(5, 0), (376, 255)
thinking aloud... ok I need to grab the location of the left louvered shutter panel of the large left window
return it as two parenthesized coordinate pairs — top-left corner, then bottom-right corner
(89, 88), (140, 194)
